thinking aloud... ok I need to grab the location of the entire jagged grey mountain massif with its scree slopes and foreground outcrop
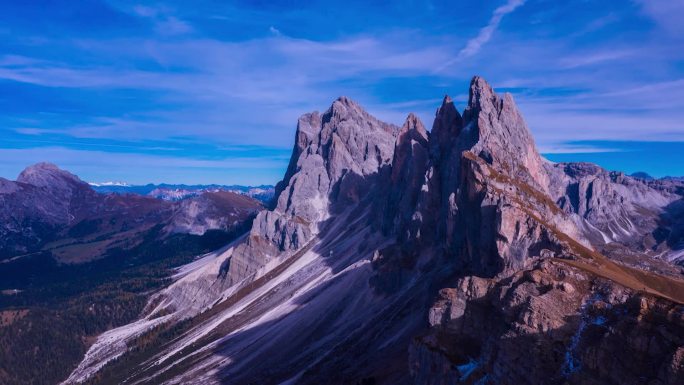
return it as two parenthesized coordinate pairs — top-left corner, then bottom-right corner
(52, 77), (684, 384)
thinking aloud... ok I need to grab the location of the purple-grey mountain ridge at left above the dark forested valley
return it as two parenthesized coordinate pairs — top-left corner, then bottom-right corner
(0, 163), (262, 263)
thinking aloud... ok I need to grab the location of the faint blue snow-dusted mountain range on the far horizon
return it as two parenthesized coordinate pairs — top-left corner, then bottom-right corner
(90, 182), (275, 204)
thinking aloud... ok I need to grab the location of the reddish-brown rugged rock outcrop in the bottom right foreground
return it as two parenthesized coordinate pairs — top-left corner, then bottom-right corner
(410, 260), (684, 385)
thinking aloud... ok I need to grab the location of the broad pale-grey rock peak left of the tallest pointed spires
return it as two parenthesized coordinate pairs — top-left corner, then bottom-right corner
(225, 97), (397, 285)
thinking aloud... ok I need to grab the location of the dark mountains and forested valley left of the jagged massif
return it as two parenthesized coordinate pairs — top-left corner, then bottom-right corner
(0, 163), (263, 385)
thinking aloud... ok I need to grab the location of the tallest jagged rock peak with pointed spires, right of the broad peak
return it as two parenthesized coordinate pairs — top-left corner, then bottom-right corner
(388, 77), (587, 276)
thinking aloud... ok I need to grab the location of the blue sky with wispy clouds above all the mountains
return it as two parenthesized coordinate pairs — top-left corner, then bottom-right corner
(0, 0), (684, 184)
